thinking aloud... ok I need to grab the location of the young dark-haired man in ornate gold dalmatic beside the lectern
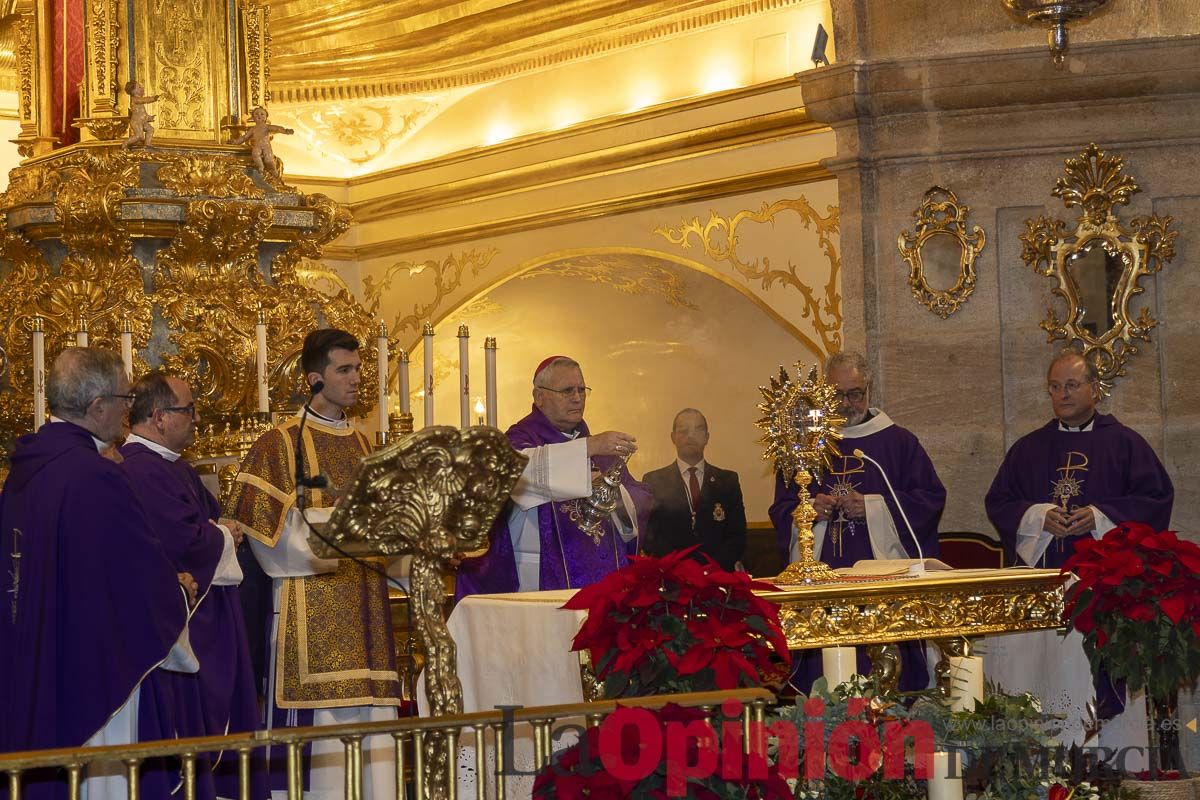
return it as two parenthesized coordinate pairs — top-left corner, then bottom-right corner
(232, 329), (401, 800)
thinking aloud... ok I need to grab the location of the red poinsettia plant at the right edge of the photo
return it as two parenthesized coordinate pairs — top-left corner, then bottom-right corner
(1062, 522), (1200, 702)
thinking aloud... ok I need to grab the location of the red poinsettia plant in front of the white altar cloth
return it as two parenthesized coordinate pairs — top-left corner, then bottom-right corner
(565, 548), (791, 698)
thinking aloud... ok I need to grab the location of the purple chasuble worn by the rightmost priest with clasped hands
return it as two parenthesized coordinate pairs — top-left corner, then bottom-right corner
(984, 414), (1175, 569)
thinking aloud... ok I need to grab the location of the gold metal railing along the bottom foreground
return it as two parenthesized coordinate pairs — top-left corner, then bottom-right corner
(0, 688), (775, 800)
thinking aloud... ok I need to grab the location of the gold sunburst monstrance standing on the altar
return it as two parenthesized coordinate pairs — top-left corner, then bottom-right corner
(757, 362), (846, 584)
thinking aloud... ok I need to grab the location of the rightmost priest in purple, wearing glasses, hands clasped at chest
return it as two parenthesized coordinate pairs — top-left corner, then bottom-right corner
(985, 348), (1175, 727)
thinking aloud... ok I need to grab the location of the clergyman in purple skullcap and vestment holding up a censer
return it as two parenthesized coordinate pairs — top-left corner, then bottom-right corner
(457, 356), (654, 597)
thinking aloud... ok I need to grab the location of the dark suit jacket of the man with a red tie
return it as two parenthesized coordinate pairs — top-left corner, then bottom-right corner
(642, 462), (746, 570)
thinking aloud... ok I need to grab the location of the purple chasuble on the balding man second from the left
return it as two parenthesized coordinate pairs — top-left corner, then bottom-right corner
(121, 441), (269, 800)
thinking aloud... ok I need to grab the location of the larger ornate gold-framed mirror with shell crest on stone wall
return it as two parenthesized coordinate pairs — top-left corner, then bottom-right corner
(1021, 143), (1178, 393)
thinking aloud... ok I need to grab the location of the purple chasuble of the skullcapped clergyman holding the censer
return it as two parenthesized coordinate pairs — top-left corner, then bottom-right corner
(456, 405), (654, 597)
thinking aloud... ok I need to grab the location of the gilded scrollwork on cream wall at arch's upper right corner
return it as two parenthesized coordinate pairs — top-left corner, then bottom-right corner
(654, 197), (841, 353)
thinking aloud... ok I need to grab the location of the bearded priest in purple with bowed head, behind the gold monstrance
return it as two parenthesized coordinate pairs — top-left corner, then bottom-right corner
(769, 351), (946, 692)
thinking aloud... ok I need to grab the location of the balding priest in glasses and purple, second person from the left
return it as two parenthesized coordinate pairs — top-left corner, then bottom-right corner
(121, 372), (270, 800)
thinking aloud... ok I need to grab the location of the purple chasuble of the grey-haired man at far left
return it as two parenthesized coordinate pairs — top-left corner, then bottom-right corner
(0, 422), (187, 796)
